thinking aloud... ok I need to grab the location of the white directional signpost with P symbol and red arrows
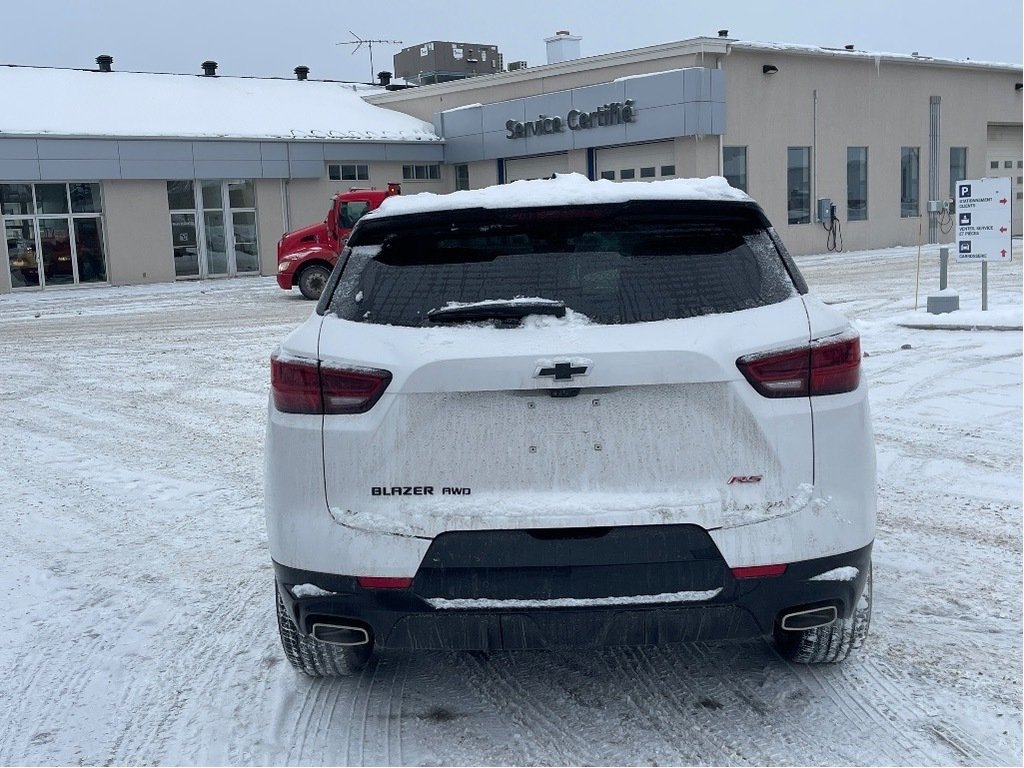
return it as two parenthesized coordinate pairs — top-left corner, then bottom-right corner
(956, 178), (1014, 309)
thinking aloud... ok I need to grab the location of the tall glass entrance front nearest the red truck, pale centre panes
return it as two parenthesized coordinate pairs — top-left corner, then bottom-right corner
(167, 179), (259, 278)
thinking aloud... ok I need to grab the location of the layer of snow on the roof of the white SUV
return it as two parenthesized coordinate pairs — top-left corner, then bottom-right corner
(367, 173), (751, 217)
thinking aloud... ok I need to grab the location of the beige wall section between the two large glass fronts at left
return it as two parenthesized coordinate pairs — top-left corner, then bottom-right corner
(103, 181), (174, 286)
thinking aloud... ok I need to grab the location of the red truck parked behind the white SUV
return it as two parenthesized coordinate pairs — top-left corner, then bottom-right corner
(278, 182), (401, 299)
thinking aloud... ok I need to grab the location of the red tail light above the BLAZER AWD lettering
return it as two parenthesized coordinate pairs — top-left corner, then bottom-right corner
(270, 353), (391, 414)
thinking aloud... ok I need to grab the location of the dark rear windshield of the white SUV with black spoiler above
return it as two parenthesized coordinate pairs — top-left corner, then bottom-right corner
(325, 201), (796, 327)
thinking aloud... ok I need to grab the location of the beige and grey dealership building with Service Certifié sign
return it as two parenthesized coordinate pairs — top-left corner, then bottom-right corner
(0, 31), (1024, 293)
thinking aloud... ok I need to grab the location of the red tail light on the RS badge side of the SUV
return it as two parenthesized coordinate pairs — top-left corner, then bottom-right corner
(736, 333), (860, 397)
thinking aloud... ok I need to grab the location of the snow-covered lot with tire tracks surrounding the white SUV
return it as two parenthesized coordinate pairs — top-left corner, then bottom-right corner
(0, 243), (1022, 765)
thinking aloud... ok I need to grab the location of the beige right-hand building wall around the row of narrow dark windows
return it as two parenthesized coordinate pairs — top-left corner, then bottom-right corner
(722, 50), (1021, 253)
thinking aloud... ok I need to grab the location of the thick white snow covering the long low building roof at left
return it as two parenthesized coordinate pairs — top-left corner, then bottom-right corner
(0, 66), (440, 141)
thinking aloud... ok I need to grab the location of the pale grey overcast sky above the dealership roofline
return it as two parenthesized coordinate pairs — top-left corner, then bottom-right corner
(0, 0), (1022, 82)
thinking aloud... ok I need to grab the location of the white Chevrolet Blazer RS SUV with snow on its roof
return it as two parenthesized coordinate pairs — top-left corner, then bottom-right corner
(266, 175), (876, 675)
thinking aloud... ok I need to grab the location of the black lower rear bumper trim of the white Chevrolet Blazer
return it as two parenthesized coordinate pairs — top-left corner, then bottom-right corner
(274, 545), (871, 650)
